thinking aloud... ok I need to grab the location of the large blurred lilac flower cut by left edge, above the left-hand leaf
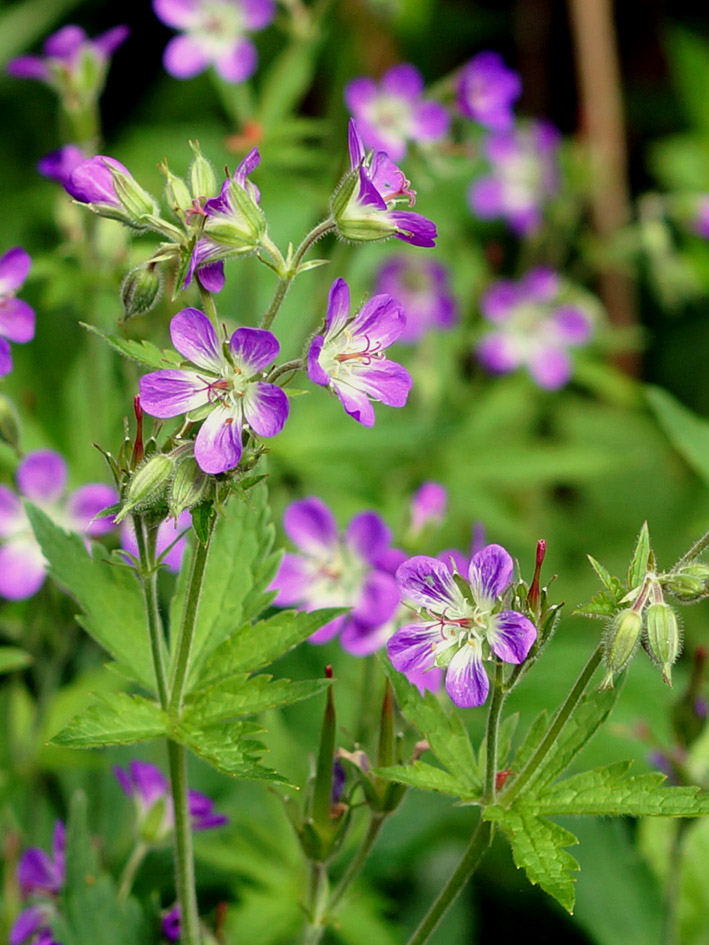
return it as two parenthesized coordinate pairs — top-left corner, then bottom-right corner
(0, 450), (118, 600)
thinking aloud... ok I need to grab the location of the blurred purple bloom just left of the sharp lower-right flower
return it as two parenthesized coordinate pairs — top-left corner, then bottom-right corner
(271, 497), (399, 656)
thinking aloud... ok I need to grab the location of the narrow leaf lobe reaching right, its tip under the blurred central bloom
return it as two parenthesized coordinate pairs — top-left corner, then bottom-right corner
(199, 607), (347, 686)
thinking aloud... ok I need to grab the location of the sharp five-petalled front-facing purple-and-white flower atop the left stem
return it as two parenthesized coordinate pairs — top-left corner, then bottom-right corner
(140, 308), (289, 474)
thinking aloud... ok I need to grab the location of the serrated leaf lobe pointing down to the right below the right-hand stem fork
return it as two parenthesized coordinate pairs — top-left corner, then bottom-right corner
(483, 805), (579, 912)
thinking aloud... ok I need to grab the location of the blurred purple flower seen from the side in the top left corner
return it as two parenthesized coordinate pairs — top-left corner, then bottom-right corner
(6, 26), (130, 101)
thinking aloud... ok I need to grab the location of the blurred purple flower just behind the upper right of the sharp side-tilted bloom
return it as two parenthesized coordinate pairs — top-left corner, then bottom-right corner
(375, 256), (458, 344)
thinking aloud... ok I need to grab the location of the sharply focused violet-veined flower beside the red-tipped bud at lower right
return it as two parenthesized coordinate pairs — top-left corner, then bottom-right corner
(387, 545), (537, 708)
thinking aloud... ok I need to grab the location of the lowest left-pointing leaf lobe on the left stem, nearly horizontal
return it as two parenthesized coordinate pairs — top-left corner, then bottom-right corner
(52, 692), (168, 748)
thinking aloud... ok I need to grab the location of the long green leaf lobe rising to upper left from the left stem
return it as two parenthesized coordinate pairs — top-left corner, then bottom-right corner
(26, 503), (155, 690)
